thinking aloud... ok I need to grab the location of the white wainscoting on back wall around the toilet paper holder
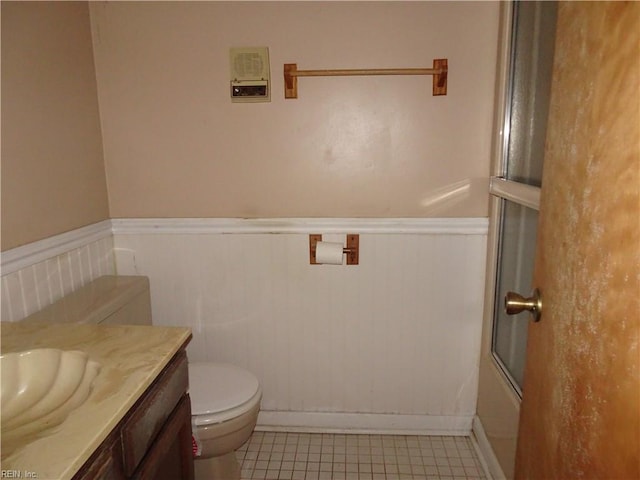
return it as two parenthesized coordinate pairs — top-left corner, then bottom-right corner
(113, 219), (487, 434)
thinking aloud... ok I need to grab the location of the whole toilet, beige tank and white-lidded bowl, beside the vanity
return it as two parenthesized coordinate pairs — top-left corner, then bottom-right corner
(23, 276), (262, 480)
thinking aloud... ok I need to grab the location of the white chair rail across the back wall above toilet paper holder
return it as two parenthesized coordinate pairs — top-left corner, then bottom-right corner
(111, 218), (489, 235)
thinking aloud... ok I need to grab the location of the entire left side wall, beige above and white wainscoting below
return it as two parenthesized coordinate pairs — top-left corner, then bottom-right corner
(0, 2), (115, 321)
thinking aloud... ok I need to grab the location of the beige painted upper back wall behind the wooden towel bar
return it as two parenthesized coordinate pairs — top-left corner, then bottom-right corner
(90, 2), (499, 217)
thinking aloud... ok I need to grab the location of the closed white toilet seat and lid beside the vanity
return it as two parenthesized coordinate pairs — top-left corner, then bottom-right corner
(189, 362), (262, 426)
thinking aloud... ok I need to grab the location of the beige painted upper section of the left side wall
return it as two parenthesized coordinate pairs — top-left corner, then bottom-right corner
(2, 2), (109, 251)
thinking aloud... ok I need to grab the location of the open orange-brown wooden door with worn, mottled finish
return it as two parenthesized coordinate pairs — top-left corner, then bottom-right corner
(516, 2), (640, 480)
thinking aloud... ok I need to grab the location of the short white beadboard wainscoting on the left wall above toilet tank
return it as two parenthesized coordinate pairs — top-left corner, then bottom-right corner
(0, 220), (115, 321)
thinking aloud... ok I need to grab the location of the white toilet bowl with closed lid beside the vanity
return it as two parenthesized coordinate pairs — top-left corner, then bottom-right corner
(189, 362), (262, 480)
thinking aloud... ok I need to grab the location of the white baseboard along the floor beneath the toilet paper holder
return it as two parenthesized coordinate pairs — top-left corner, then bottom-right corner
(256, 410), (473, 436)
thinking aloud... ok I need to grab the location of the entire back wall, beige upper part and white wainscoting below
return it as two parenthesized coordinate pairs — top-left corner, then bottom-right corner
(95, 2), (499, 433)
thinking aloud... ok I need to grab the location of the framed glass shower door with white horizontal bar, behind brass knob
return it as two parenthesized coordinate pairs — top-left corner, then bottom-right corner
(490, 2), (556, 396)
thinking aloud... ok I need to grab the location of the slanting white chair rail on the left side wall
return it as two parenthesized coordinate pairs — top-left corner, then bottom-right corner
(0, 220), (112, 275)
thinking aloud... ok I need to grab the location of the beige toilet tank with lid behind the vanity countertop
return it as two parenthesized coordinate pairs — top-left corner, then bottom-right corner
(22, 275), (151, 325)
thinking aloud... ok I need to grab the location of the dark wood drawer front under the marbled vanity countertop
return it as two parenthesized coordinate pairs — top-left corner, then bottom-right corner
(122, 351), (189, 477)
